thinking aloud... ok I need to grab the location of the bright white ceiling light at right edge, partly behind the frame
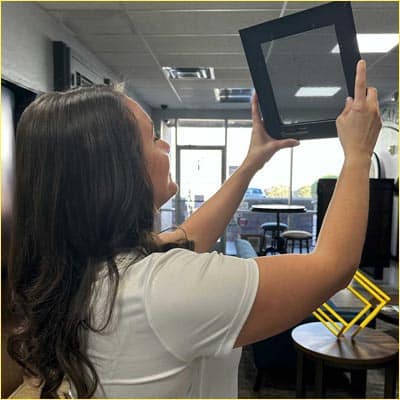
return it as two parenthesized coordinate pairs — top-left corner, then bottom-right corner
(331, 33), (399, 53)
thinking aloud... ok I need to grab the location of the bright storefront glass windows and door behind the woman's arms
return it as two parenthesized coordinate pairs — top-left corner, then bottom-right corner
(161, 119), (343, 254)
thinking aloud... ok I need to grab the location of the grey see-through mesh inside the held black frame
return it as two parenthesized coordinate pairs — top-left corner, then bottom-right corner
(261, 25), (347, 125)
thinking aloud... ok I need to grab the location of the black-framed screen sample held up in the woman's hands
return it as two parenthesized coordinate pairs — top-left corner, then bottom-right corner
(239, 1), (360, 140)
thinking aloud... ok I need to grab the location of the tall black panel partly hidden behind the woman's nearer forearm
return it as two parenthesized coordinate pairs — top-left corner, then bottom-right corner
(317, 179), (394, 279)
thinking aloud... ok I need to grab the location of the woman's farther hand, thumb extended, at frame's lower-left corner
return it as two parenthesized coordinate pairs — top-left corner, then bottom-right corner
(243, 93), (300, 173)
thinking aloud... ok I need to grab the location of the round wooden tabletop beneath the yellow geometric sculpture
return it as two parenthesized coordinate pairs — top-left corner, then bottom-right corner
(292, 322), (399, 366)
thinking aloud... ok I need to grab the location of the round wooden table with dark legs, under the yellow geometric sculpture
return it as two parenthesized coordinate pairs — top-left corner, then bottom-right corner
(292, 322), (399, 398)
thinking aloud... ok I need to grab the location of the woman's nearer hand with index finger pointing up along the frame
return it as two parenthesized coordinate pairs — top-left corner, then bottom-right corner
(336, 60), (382, 159)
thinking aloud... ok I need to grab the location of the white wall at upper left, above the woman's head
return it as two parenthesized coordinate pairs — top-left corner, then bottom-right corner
(1, 2), (151, 112)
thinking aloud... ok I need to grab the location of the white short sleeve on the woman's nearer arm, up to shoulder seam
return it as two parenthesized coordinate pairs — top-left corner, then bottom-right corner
(145, 249), (258, 361)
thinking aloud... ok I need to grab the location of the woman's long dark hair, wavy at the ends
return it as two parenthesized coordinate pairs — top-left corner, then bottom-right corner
(8, 86), (190, 397)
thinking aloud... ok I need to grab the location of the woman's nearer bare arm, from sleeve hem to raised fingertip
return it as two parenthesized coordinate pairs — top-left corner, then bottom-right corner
(235, 61), (381, 347)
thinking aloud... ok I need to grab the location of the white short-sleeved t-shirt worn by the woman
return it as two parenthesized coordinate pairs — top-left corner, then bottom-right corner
(88, 249), (258, 398)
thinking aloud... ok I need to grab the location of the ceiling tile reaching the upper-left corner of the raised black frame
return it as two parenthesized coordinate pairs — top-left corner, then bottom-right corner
(128, 10), (279, 35)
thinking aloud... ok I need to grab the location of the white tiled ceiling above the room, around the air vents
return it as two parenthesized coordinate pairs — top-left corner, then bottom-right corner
(39, 1), (398, 114)
